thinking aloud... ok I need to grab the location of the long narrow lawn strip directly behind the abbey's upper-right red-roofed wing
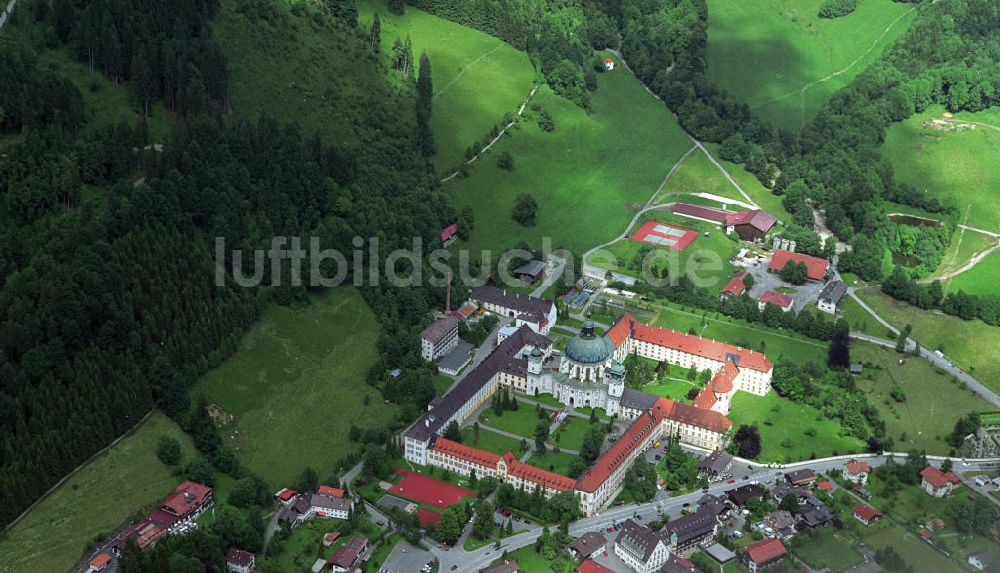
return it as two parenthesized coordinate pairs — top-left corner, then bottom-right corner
(653, 305), (827, 363)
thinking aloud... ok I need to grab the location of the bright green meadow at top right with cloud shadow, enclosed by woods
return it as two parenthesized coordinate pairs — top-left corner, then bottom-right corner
(708, 0), (914, 131)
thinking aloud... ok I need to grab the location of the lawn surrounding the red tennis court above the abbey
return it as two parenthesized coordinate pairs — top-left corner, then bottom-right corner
(587, 210), (739, 289)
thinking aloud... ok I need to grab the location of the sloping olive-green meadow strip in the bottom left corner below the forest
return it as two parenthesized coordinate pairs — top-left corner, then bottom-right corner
(0, 412), (195, 573)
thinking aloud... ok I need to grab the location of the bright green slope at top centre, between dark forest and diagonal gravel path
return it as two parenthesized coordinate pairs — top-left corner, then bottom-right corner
(356, 0), (535, 170)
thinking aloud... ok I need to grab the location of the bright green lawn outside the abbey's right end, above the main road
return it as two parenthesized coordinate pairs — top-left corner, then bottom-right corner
(729, 390), (865, 462)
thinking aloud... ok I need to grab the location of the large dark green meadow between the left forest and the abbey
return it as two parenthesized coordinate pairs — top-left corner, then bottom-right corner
(191, 288), (398, 486)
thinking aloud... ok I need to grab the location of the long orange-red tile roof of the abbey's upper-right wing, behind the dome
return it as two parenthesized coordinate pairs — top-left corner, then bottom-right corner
(607, 314), (774, 372)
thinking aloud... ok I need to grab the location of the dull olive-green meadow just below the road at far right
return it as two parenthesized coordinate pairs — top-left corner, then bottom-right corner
(851, 341), (991, 455)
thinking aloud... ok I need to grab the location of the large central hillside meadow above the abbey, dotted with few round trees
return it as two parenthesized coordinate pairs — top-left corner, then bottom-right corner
(445, 55), (691, 253)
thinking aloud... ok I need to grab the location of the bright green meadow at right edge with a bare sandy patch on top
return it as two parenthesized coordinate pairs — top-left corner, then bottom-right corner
(882, 107), (1000, 233)
